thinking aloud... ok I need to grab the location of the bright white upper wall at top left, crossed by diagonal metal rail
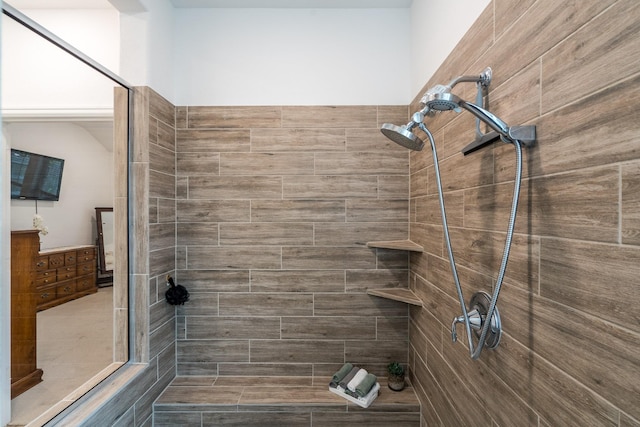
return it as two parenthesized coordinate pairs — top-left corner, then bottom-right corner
(1, 9), (120, 115)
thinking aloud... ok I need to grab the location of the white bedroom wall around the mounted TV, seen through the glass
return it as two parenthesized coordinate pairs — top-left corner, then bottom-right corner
(5, 122), (114, 249)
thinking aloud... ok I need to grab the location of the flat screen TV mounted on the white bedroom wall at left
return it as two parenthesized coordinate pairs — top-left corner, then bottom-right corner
(11, 149), (64, 201)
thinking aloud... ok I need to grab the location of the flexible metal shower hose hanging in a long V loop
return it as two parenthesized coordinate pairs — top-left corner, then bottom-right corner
(419, 123), (522, 360)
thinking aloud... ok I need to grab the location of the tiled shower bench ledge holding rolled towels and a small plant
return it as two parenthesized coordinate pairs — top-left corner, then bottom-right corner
(153, 376), (420, 427)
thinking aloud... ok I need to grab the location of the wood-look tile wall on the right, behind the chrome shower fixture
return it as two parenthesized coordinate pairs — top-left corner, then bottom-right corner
(409, 0), (640, 426)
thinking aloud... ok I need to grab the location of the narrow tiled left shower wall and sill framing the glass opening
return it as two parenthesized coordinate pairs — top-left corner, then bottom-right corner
(64, 87), (176, 426)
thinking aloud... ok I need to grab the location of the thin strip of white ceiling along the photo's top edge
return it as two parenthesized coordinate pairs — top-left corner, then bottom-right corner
(6, 0), (413, 9)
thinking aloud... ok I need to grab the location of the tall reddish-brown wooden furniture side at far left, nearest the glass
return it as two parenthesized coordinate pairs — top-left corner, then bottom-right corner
(11, 230), (42, 399)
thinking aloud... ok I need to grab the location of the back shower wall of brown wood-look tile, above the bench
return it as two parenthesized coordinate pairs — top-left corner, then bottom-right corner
(172, 106), (409, 376)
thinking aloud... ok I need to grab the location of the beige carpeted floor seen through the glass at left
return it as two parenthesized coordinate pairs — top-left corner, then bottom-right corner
(9, 287), (113, 426)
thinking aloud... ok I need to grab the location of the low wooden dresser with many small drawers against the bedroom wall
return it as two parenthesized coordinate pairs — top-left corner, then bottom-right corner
(34, 246), (98, 311)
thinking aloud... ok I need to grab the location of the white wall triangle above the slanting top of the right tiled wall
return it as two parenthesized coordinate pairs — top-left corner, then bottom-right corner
(407, 0), (491, 97)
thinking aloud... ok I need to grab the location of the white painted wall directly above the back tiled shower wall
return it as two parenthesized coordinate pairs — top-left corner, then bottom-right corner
(174, 9), (411, 105)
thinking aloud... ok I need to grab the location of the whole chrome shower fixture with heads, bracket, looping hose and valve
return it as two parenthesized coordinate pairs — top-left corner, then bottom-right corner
(380, 68), (536, 360)
